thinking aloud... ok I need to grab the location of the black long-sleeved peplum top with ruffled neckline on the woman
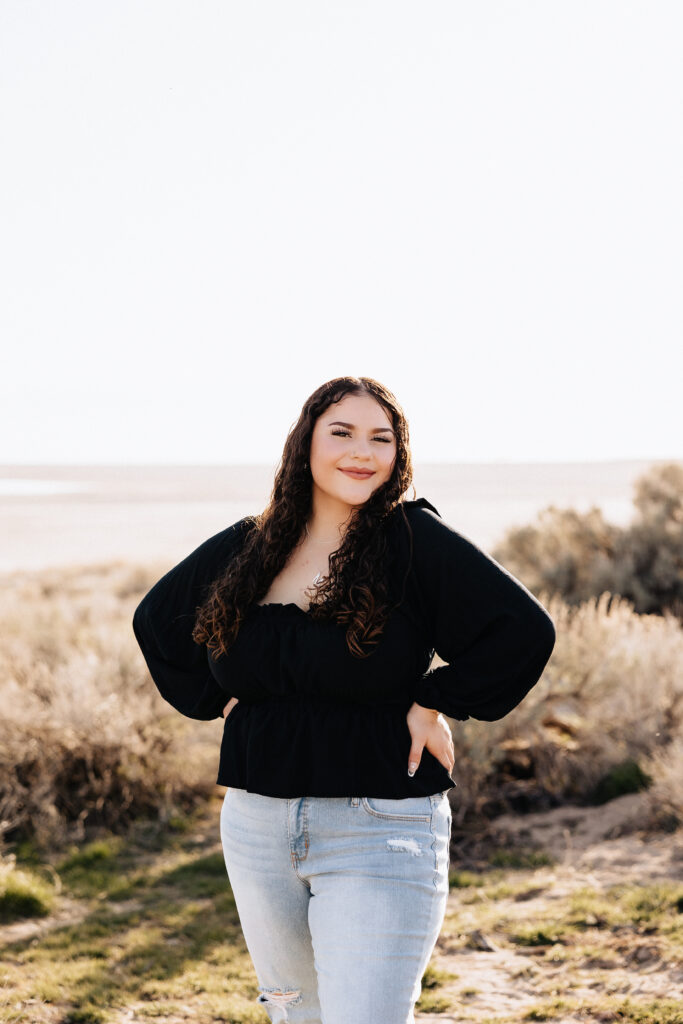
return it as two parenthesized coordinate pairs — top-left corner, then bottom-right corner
(133, 498), (555, 798)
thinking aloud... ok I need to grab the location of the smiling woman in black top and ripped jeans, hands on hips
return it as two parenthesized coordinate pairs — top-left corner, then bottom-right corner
(133, 377), (555, 1024)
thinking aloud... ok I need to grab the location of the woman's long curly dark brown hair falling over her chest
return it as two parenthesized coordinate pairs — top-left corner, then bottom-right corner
(193, 377), (415, 657)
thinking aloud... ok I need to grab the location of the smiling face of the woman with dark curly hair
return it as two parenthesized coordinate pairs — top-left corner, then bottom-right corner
(309, 394), (396, 506)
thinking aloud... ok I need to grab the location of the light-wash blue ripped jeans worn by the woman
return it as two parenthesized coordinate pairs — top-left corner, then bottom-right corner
(220, 787), (452, 1024)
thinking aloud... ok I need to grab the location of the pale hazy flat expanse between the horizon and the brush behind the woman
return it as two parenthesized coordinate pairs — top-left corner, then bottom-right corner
(0, 460), (670, 571)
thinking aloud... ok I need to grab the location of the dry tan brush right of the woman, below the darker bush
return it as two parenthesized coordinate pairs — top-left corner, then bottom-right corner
(452, 594), (683, 822)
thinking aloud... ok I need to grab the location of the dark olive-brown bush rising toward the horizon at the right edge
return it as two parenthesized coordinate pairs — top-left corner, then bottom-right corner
(492, 462), (683, 622)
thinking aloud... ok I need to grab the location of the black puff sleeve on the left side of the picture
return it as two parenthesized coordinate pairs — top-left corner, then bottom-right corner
(133, 519), (246, 721)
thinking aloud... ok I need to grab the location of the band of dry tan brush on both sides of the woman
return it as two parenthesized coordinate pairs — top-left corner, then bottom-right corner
(0, 563), (683, 846)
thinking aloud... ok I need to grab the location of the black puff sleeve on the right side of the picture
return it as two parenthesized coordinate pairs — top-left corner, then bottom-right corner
(410, 502), (556, 722)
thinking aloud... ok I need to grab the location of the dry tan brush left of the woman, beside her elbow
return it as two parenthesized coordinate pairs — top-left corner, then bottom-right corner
(0, 563), (219, 846)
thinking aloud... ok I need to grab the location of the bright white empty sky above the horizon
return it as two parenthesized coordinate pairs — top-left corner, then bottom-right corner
(0, 0), (683, 463)
